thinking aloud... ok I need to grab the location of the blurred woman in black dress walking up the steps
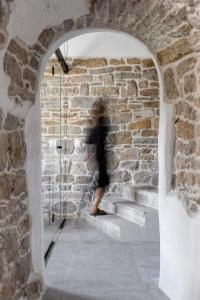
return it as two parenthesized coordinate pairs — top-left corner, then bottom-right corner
(86, 101), (110, 215)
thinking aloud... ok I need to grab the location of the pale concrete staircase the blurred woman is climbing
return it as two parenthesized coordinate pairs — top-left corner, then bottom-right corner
(81, 185), (159, 241)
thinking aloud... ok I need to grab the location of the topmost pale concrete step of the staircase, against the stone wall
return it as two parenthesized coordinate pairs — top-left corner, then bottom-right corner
(123, 185), (158, 209)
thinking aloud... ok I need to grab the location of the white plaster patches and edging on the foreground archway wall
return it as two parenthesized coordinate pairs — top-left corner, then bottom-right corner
(0, 0), (200, 300)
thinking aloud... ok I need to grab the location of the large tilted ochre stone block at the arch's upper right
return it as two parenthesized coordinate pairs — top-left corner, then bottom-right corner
(157, 38), (192, 65)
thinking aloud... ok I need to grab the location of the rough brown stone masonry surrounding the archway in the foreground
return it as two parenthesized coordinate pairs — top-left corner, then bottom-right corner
(0, 0), (200, 300)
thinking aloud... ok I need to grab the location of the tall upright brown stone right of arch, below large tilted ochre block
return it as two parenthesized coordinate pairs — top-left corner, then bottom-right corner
(164, 68), (179, 100)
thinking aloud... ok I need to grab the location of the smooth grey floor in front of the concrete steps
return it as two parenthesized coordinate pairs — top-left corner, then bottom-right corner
(43, 220), (168, 300)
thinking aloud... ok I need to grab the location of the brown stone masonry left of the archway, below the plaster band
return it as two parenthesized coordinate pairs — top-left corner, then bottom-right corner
(0, 112), (31, 299)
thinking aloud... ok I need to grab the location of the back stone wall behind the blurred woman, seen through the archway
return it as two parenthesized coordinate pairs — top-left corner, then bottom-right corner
(41, 58), (159, 211)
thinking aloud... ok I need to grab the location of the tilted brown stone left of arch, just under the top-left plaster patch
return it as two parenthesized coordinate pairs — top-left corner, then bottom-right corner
(8, 39), (28, 65)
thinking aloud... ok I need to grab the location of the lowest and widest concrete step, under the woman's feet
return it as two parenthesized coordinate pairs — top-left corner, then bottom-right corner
(81, 210), (159, 241)
